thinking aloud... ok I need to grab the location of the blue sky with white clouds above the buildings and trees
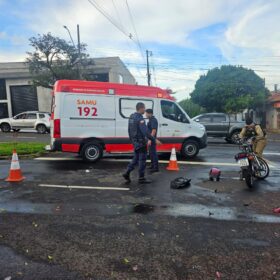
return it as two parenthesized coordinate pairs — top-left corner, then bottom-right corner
(0, 0), (280, 100)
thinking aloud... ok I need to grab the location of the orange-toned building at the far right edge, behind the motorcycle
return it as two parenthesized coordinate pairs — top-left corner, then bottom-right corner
(266, 90), (280, 132)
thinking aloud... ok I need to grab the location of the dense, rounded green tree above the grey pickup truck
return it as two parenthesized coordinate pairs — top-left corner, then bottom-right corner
(191, 65), (268, 113)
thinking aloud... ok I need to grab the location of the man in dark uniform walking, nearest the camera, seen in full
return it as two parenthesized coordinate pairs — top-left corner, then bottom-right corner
(123, 102), (155, 184)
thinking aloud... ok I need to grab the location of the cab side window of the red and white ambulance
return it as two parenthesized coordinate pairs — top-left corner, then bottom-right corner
(161, 100), (188, 122)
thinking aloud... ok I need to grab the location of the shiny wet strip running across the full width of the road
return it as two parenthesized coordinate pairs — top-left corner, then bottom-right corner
(0, 194), (280, 223)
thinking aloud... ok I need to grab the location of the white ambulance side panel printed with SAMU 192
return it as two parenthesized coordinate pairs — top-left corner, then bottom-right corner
(61, 94), (116, 138)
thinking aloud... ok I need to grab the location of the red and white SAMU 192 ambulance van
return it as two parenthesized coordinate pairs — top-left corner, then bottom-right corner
(51, 80), (207, 162)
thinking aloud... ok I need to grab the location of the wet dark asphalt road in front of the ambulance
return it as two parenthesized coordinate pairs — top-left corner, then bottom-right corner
(0, 139), (280, 280)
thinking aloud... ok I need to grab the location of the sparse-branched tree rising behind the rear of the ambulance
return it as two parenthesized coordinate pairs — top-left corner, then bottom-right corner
(26, 33), (93, 88)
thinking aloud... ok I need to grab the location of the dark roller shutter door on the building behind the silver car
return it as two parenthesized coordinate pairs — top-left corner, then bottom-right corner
(10, 86), (38, 116)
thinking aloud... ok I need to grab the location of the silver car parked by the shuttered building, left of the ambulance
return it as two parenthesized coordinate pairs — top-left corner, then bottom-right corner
(0, 112), (50, 134)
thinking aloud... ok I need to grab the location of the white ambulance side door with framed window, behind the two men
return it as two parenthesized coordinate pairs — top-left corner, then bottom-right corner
(116, 97), (154, 138)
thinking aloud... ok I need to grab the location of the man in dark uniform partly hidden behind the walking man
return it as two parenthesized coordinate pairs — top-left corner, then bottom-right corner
(146, 109), (159, 173)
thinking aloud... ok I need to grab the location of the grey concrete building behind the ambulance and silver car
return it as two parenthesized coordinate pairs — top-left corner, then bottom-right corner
(0, 57), (136, 118)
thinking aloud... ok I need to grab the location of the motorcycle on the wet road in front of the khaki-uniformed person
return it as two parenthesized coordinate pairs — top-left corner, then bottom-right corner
(235, 138), (270, 188)
